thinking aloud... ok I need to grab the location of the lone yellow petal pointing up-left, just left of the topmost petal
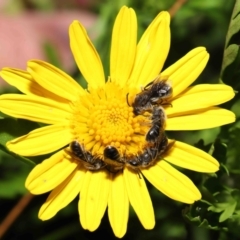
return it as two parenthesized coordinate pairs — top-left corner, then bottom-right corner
(69, 21), (105, 88)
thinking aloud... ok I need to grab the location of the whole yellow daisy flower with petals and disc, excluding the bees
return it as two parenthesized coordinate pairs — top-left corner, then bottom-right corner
(0, 7), (235, 237)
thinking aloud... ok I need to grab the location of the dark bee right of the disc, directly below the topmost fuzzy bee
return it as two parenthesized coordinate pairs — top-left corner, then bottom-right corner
(146, 106), (166, 143)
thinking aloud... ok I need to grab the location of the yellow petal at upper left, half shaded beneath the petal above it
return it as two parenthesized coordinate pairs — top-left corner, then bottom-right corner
(0, 68), (69, 102)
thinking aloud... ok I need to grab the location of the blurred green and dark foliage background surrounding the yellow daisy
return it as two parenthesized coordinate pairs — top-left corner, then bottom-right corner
(0, 0), (240, 240)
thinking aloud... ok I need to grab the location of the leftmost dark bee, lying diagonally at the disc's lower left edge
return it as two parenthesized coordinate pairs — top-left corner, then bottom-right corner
(70, 140), (106, 171)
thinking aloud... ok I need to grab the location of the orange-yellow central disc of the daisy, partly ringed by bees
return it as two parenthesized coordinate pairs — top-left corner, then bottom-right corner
(71, 81), (150, 156)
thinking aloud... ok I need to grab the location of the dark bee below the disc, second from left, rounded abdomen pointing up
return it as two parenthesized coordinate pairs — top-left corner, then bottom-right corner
(103, 145), (124, 172)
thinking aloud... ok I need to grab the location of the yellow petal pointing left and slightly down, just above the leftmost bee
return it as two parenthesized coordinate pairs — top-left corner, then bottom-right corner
(7, 124), (73, 156)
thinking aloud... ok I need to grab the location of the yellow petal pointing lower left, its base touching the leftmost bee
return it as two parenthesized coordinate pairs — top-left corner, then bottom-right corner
(25, 151), (77, 194)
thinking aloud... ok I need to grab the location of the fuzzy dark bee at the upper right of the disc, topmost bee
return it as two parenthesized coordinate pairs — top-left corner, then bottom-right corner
(132, 76), (172, 115)
